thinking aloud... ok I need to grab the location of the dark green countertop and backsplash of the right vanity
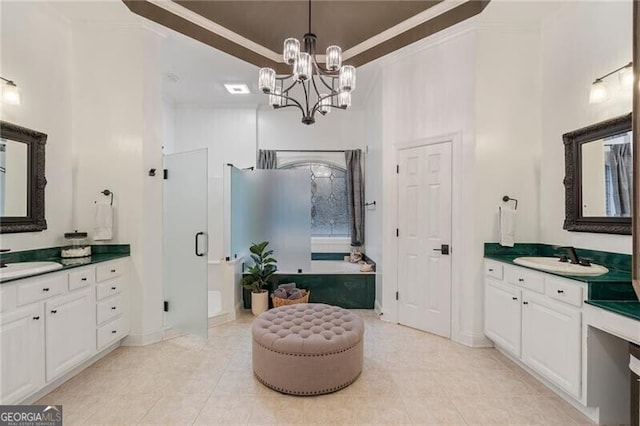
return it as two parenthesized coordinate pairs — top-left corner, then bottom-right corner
(484, 243), (640, 321)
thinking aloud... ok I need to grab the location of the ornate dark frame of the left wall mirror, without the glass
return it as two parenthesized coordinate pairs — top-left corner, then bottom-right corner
(0, 121), (47, 234)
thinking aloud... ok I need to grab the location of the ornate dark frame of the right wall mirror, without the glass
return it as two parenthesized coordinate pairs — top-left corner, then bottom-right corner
(562, 114), (636, 235)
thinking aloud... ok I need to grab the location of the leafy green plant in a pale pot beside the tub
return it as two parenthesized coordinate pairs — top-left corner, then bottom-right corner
(240, 241), (278, 315)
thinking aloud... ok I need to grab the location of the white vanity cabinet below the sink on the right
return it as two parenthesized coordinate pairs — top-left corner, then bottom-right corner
(485, 259), (585, 400)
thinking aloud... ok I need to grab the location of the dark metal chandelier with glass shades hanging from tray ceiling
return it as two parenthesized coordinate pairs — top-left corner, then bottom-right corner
(258, 0), (356, 125)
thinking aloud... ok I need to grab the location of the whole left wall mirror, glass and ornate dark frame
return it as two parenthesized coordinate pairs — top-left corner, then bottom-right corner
(0, 121), (47, 233)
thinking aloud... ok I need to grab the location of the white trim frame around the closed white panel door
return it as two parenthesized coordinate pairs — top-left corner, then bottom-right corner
(389, 132), (462, 341)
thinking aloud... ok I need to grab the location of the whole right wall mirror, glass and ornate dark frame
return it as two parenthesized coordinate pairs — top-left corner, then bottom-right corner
(562, 114), (633, 235)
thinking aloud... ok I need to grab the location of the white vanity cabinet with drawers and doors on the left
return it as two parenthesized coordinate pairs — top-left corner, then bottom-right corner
(0, 258), (129, 405)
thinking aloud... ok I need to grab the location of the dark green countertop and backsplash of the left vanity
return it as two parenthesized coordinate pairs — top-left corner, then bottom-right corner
(0, 244), (131, 285)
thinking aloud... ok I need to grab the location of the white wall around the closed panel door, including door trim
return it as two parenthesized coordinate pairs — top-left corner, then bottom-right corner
(382, 22), (482, 343)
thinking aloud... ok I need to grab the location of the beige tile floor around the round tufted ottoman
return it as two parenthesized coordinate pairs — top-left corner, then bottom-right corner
(38, 311), (592, 426)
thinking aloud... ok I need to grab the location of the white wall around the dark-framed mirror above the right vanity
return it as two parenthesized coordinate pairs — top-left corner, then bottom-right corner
(540, 1), (632, 253)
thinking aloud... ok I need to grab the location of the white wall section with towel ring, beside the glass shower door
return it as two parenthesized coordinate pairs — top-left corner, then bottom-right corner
(73, 23), (163, 344)
